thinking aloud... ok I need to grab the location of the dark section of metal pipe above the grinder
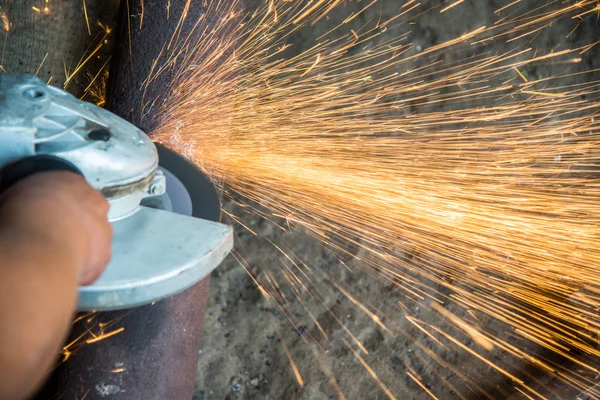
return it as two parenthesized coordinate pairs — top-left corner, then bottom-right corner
(107, 0), (210, 132)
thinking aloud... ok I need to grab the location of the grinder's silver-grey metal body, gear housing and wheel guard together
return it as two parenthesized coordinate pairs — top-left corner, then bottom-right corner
(0, 73), (233, 311)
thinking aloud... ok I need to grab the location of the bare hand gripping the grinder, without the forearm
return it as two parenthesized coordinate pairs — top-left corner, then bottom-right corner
(0, 171), (112, 285)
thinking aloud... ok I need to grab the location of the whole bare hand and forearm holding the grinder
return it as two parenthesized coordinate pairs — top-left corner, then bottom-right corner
(0, 171), (112, 399)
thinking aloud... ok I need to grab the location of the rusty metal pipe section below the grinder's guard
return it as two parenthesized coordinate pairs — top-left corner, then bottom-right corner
(34, 277), (210, 400)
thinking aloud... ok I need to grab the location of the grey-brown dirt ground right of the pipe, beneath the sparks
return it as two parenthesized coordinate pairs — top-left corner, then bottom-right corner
(195, 0), (600, 400)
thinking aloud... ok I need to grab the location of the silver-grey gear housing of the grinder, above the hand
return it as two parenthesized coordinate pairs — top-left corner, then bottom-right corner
(0, 73), (158, 199)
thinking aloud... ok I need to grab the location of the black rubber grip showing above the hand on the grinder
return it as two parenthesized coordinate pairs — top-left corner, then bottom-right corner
(0, 154), (83, 194)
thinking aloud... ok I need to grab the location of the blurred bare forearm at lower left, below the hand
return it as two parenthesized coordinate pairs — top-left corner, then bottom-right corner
(0, 226), (81, 400)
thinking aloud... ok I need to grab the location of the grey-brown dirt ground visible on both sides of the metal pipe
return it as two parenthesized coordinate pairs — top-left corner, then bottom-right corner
(0, 0), (600, 400)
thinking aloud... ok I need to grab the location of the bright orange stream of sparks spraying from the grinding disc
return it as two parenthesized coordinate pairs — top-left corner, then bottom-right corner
(142, 0), (600, 398)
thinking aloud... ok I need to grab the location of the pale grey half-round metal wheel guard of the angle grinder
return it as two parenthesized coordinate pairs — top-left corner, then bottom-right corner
(78, 207), (233, 311)
